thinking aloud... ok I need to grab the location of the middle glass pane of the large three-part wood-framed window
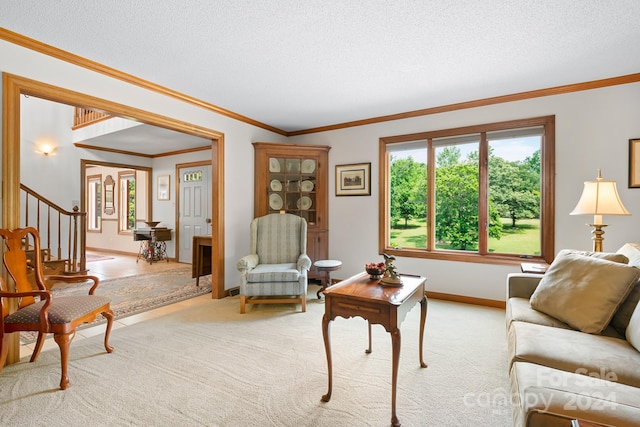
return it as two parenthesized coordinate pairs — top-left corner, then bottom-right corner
(433, 135), (480, 251)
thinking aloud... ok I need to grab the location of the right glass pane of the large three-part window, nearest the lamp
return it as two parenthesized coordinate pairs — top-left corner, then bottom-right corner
(487, 133), (543, 255)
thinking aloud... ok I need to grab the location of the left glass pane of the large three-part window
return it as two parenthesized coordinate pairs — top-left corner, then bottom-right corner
(387, 141), (428, 249)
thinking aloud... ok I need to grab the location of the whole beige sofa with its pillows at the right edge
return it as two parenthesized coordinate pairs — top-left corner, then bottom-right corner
(506, 244), (640, 427)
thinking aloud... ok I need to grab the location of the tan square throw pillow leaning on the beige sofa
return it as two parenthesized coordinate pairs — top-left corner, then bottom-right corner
(530, 253), (640, 334)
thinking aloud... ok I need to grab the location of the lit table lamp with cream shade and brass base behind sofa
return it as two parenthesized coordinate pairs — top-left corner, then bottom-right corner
(569, 169), (631, 252)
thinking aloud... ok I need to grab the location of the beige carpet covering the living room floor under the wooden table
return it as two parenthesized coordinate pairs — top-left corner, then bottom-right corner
(0, 286), (511, 427)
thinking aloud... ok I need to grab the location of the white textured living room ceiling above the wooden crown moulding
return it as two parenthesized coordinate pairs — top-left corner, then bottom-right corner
(0, 0), (640, 131)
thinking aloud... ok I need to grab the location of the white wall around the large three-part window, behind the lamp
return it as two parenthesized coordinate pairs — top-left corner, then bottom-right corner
(290, 83), (640, 300)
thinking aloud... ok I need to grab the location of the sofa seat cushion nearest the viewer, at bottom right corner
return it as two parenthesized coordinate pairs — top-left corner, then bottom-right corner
(510, 362), (640, 427)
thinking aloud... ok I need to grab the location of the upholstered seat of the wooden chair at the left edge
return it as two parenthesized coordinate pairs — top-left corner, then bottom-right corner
(4, 295), (111, 324)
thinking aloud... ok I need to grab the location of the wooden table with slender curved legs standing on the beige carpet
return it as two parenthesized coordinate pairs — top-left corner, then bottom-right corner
(322, 273), (427, 427)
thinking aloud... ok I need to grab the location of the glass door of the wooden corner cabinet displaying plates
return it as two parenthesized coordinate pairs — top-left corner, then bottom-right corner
(269, 157), (317, 225)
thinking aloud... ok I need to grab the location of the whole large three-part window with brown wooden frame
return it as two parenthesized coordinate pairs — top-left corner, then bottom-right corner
(380, 116), (555, 264)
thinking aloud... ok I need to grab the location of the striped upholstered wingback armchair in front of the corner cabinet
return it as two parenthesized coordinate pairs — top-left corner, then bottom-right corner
(238, 214), (311, 313)
